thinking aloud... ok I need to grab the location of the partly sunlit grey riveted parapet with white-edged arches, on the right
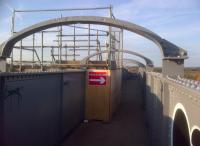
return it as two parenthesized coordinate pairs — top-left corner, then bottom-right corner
(146, 72), (200, 146)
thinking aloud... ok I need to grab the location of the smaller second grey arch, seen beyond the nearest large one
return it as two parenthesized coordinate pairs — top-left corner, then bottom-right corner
(81, 50), (153, 67)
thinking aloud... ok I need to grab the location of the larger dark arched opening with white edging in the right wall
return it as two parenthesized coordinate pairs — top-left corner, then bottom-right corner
(173, 109), (190, 146)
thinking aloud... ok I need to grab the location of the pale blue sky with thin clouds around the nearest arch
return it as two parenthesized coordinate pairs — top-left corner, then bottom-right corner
(0, 0), (200, 67)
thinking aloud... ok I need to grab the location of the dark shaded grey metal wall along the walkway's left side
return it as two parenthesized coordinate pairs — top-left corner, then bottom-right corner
(0, 71), (85, 146)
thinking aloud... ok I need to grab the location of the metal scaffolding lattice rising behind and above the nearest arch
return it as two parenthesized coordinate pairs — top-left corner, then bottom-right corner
(8, 6), (123, 71)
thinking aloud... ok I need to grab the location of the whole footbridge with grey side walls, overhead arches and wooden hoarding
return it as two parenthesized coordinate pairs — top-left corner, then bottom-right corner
(0, 7), (200, 146)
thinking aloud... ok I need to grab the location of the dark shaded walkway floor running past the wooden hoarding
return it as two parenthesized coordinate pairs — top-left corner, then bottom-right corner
(61, 74), (148, 146)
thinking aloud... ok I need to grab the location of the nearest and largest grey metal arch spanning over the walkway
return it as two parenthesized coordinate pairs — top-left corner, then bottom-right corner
(0, 16), (187, 59)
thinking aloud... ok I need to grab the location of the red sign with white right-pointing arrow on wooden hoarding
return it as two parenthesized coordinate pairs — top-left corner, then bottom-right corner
(88, 71), (107, 85)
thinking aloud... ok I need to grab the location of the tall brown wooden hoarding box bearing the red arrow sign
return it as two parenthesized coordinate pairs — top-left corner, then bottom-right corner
(85, 69), (121, 122)
